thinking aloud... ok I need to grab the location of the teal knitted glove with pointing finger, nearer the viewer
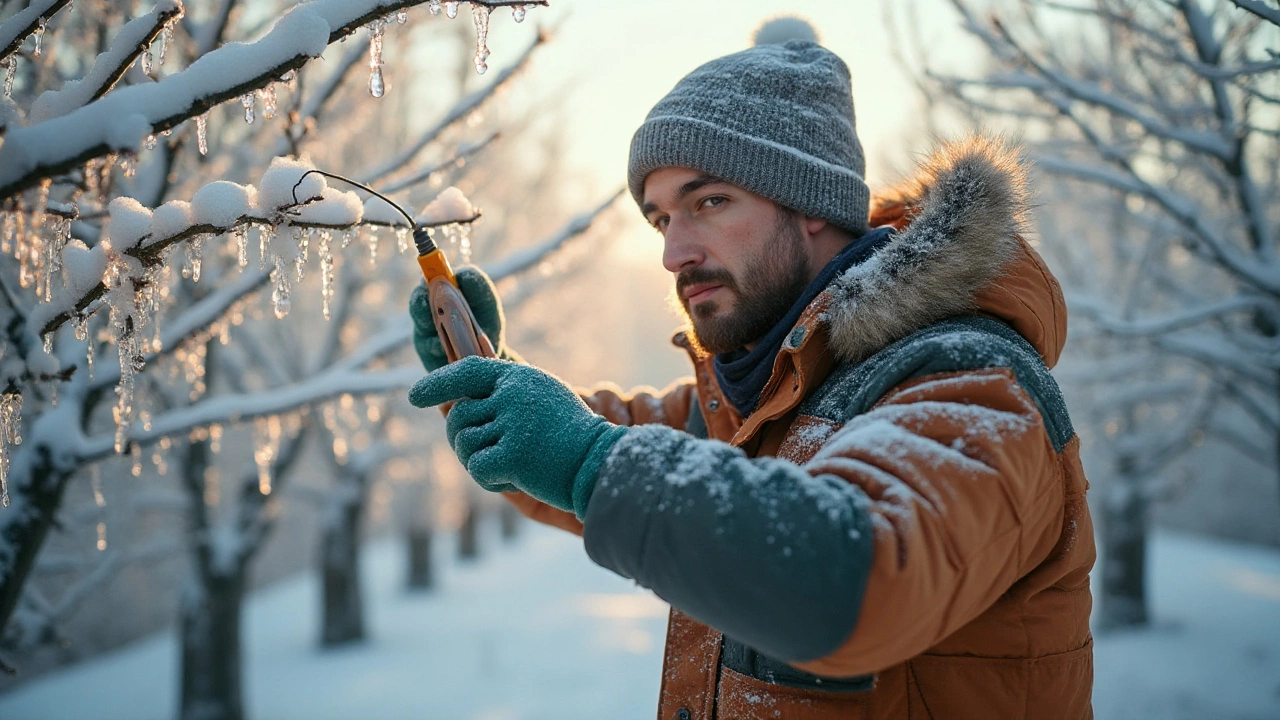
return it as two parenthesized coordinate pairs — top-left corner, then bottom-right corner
(408, 357), (627, 520)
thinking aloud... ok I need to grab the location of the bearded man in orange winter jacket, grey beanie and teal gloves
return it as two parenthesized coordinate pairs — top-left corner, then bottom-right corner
(411, 25), (1094, 720)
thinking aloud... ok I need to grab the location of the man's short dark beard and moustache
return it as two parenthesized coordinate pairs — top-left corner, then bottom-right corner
(676, 210), (809, 355)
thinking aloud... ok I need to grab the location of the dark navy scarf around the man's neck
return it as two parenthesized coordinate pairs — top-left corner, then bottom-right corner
(714, 227), (893, 418)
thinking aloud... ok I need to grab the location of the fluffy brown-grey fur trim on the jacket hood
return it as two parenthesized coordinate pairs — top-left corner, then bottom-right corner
(827, 137), (1029, 361)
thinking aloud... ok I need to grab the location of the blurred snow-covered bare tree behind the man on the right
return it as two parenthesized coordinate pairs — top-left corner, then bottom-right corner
(915, 0), (1280, 625)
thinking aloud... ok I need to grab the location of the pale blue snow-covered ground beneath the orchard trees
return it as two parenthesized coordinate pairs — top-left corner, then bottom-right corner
(0, 527), (1280, 720)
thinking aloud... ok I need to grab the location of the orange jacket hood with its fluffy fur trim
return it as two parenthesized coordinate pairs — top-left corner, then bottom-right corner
(820, 137), (1066, 366)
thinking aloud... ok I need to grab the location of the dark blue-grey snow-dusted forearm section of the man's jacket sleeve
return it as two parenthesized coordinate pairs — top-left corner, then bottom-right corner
(584, 425), (873, 662)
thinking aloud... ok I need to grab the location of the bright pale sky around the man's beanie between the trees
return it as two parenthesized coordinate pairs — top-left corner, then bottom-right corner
(471, 0), (973, 259)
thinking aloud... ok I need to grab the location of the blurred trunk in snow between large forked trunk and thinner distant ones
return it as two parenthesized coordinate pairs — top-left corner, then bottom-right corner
(320, 478), (365, 647)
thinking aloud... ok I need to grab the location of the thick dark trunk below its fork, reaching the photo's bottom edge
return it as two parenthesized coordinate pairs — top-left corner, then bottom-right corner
(179, 568), (244, 720)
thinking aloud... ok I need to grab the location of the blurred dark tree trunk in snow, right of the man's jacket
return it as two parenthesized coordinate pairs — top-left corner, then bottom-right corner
(1100, 459), (1149, 629)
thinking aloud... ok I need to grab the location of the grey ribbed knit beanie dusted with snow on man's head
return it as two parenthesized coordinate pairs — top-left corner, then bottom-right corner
(627, 25), (870, 234)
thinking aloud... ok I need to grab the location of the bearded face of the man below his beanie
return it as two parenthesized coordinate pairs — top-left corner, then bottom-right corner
(641, 168), (812, 354)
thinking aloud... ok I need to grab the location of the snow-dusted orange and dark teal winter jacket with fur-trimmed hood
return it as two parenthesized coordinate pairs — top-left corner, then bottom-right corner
(508, 140), (1094, 720)
